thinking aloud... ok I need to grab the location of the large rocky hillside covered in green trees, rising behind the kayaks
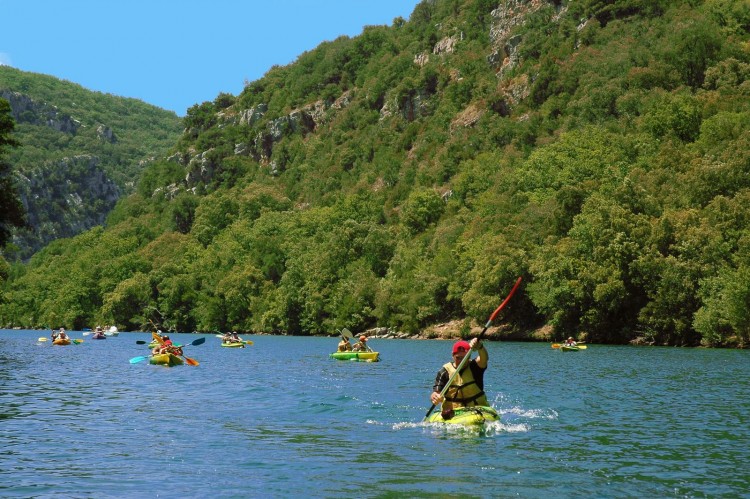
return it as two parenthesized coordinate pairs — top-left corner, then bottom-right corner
(0, 0), (750, 346)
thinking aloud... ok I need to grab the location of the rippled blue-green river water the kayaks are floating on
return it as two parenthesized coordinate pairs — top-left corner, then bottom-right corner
(0, 330), (750, 497)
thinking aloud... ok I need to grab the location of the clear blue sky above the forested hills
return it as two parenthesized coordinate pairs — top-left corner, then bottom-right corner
(0, 0), (419, 116)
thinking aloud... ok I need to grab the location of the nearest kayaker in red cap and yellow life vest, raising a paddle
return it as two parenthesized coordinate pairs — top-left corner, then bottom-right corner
(430, 338), (489, 419)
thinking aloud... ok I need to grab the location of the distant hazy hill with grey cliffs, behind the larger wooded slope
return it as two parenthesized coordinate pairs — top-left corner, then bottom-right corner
(0, 66), (182, 260)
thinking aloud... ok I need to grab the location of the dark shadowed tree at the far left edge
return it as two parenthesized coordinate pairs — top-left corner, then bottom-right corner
(0, 99), (25, 248)
